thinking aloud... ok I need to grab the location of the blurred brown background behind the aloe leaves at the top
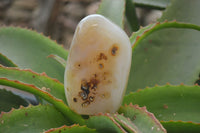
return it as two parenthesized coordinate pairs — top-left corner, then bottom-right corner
(0, 0), (162, 49)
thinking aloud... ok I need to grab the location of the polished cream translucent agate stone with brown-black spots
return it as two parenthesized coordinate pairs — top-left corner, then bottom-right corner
(64, 15), (132, 115)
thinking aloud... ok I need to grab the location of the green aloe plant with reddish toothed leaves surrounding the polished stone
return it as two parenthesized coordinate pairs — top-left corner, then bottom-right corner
(0, 0), (200, 133)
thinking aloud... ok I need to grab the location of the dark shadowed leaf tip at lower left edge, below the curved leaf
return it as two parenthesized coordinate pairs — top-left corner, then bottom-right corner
(0, 89), (28, 112)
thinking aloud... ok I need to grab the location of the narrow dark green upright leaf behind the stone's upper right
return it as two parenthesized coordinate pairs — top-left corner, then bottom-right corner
(126, 0), (140, 31)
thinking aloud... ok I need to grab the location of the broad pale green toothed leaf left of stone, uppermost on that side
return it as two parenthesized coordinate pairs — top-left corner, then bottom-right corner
(0, 27), (68, 82)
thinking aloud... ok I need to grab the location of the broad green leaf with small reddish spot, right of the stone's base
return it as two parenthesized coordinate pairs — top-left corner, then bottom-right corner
(123, 85), (200, 123)
